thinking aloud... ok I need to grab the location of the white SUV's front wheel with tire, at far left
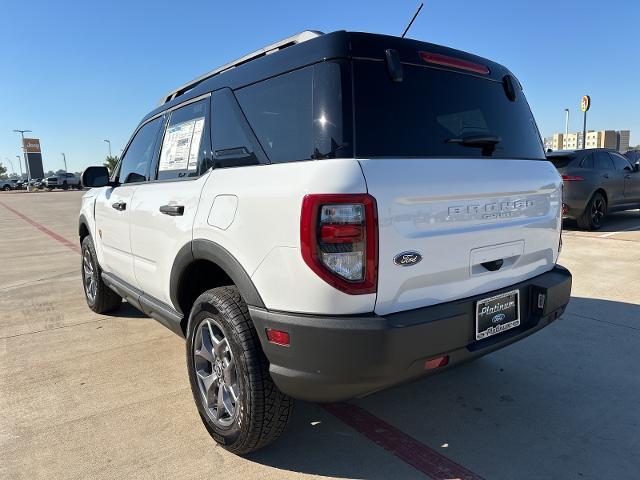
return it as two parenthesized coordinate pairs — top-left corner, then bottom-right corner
(80, 236), (122, 313)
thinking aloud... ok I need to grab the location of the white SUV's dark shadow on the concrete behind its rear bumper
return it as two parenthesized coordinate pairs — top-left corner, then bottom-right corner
(247, 297), (640, 479)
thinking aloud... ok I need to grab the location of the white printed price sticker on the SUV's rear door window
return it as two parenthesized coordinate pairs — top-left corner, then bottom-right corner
(158, 117), (204, 172)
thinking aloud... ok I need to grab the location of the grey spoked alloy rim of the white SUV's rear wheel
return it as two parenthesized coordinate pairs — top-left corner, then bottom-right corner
(193, 318), (240, 427)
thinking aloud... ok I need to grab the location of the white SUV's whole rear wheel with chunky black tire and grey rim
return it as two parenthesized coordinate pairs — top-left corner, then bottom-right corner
(186, 286), (293, 455)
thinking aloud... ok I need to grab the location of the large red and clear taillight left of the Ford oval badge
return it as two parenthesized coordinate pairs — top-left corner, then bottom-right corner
(300, 194), (378, 295)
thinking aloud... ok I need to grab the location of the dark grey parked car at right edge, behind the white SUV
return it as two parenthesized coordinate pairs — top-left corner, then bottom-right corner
(547, 148), (640, 230)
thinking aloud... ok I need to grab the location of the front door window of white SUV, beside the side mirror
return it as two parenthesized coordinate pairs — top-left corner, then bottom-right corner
(118, 118), (162, 183)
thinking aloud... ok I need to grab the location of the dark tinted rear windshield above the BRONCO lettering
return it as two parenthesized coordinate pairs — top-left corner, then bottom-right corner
(353, 60), (545, 159)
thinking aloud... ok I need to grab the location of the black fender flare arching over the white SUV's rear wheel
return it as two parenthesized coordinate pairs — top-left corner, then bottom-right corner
(169, 239), (265, 314)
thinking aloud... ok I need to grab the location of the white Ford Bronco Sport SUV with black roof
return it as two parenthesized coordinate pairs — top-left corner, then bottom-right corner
(80, 32), (571, 453)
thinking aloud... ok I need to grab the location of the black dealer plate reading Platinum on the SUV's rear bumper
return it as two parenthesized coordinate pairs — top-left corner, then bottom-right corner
(476, 290), (520, 340)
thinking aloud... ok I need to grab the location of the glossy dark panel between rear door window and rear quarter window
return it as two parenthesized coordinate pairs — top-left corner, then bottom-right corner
(211, 88), (269, 168)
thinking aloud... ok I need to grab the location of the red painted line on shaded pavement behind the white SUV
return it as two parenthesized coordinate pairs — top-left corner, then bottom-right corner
(322, 403), (482, 480)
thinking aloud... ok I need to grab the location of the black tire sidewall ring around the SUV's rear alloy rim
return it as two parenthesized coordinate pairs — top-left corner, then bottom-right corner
(187, 296), (251, 446)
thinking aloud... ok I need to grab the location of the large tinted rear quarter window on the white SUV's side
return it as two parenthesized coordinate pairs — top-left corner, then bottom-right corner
(235, 67), (313, 163)
